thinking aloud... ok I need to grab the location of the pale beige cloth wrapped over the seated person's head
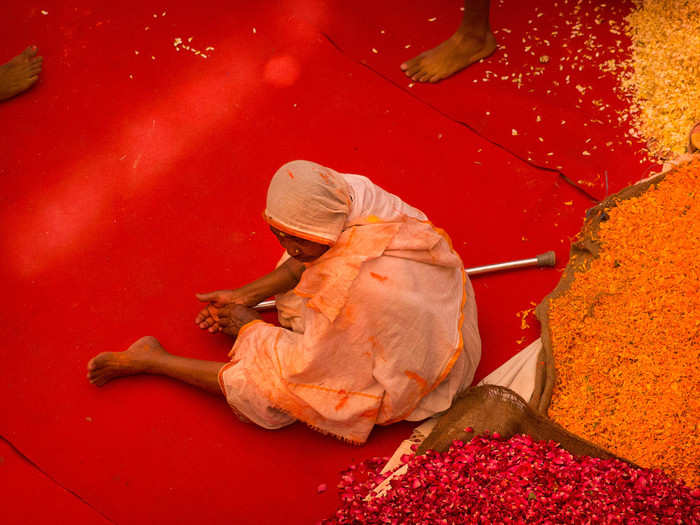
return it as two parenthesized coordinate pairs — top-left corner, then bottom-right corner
(263, 160), (351, 245)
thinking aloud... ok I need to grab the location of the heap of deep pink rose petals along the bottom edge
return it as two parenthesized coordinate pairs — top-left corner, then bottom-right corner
(322, 434), (700, 525)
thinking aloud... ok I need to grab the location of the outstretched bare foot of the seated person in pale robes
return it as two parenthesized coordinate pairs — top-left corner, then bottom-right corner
(87, 336), (168, 386)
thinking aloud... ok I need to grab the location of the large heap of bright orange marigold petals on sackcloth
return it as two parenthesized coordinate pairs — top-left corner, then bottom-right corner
(549, 159), (700, 487)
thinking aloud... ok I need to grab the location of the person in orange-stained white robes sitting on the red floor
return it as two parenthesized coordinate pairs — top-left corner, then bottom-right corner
(88, 161), (481, 443)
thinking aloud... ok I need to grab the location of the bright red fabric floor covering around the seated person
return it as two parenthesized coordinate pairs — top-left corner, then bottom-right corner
(0, 0), (651, 524)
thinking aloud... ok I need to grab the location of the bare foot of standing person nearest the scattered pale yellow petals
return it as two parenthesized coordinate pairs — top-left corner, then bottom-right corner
(401, 28), (497, 82)
